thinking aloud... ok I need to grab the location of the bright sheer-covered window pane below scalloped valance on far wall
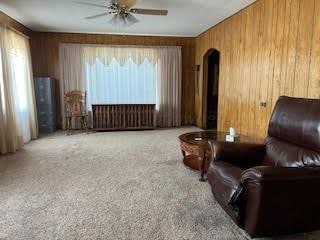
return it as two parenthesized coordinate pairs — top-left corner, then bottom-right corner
(85, 58), (156, 107)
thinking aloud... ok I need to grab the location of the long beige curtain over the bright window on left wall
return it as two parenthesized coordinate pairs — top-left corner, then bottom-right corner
(0, 26), (38, 154)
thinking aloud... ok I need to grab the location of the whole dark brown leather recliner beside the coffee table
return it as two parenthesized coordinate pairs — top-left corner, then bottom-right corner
(208, 97), (320, 237)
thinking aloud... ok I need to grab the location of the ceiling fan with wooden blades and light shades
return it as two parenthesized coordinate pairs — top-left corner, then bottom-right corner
(77, 0), (168, 26)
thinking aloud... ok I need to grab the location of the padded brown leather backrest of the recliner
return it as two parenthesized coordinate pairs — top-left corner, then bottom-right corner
(264, 96), (320, 167)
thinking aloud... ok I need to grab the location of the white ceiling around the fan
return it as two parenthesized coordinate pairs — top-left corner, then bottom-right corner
(0, 0), (255, 36)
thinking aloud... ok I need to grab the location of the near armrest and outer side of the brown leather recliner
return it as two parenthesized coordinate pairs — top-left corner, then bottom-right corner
(239, 166), (320, 237)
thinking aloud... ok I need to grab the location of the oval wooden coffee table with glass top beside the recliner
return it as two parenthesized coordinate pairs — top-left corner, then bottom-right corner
(179, 131), (254, 182)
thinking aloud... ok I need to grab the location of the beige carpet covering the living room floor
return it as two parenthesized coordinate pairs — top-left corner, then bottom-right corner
(0, 128), (320, 240)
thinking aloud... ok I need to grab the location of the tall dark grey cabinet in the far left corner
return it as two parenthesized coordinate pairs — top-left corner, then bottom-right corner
(34, 77), (57, 133)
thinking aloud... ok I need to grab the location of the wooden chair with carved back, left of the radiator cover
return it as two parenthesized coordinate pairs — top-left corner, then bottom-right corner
(64, 91), (88, 135)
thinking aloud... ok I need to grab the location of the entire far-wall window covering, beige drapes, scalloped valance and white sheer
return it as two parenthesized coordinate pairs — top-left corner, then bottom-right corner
(60, 44), (182, 127)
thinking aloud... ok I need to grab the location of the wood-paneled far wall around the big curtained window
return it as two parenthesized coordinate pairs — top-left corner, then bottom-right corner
(31, 32), (195, 125)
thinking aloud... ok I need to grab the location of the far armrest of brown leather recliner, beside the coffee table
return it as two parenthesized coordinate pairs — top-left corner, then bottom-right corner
(215, 142), (266, 166)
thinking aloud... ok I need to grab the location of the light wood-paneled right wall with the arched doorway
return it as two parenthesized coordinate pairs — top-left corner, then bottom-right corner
(195, 0), (320, 139)
